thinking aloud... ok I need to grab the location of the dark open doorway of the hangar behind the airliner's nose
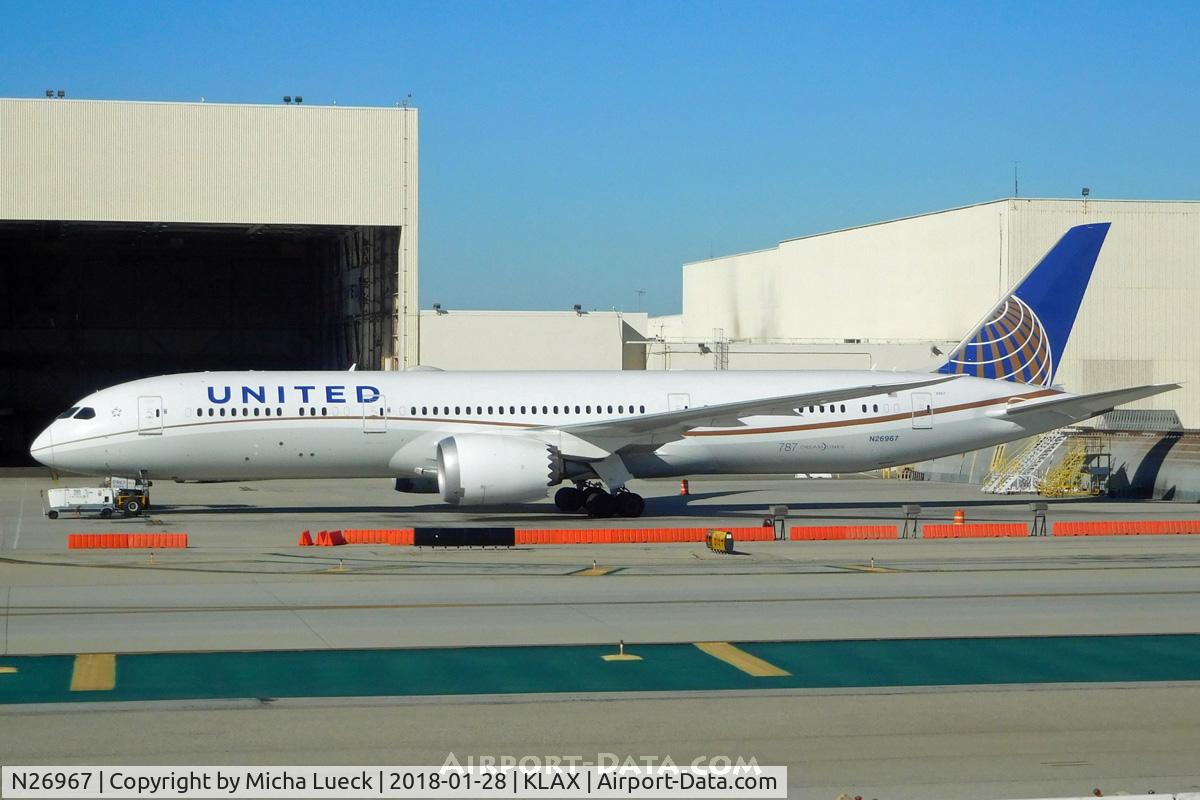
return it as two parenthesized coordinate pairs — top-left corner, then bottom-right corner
(0, 221), (400, 467)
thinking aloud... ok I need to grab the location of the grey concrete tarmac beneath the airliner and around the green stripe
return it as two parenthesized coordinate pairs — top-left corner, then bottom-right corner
(0, 476), (1200, 798)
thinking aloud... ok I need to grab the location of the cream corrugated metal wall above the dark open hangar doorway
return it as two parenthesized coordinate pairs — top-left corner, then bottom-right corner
(0, 100), (416, 225)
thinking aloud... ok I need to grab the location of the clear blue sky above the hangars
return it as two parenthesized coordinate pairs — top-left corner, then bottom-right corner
(0, 0), (1200, 313)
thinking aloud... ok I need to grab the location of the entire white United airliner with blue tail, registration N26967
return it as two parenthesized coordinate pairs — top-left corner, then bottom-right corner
(30, 223), (1177, 517)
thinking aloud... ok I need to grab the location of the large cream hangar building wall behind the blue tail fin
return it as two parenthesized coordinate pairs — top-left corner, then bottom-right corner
(676, 199), (1200, 428)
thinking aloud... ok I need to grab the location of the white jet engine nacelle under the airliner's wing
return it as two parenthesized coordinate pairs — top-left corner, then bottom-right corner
(438, 434), (562, 505)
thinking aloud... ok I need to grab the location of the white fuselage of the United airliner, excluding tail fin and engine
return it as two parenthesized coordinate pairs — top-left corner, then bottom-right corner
(31, 371), (1062, 480)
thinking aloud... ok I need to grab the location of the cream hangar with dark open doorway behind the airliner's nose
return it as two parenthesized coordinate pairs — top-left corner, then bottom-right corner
(0, 92), (418, 464)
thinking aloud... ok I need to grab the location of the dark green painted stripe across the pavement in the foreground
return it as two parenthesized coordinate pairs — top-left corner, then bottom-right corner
(0, 634), (1200, 704)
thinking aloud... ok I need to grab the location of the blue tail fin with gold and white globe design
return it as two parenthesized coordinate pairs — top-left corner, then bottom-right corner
(937, 222), (1110, 386)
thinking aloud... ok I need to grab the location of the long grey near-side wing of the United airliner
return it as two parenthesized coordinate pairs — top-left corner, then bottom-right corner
(554, 375), (958, 452)
